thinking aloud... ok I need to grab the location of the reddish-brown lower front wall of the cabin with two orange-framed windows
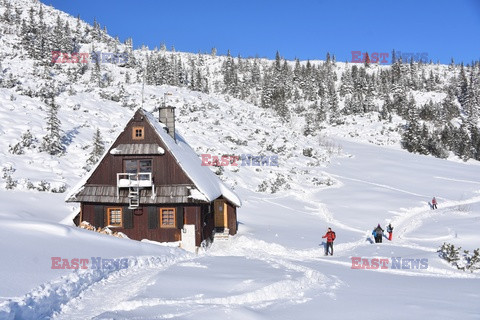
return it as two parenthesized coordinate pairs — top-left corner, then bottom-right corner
(81, 203), (213, 246)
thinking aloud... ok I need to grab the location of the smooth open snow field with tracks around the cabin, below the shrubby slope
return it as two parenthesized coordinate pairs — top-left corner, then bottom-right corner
(0, 125), (480, 319)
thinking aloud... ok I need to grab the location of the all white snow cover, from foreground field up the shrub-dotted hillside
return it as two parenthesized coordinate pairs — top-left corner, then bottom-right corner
(0, 0), (480, 320)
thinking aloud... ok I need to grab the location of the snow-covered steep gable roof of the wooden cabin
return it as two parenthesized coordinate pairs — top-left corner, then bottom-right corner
(67, 109), (241, 207)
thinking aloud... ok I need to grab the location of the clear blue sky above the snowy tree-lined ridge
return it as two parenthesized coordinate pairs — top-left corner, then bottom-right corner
(41, 0), (480, 63)
